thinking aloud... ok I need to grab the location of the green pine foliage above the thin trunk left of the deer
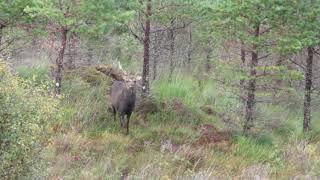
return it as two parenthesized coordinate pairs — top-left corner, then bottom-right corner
(24, 0), (133, 39)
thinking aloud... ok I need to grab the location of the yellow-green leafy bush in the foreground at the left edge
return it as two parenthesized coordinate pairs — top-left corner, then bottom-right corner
(0, 62), (58, 178)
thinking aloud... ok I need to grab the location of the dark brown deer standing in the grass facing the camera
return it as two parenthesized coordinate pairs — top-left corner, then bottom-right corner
(111, 81), (136, 134)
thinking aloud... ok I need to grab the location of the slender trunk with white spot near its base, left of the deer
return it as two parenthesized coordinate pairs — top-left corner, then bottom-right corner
(55, 28), (68, 95)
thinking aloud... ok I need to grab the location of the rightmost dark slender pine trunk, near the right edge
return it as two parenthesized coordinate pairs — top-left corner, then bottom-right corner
(303, 47), (313, 132)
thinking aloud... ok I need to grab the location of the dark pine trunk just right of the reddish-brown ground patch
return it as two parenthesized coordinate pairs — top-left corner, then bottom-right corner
(243, 24), (260, 134)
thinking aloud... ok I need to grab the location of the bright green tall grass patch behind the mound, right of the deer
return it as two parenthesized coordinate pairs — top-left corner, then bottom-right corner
(153, 74), (241, 112)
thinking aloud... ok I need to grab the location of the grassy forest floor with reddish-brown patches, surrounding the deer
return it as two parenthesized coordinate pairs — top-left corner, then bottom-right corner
(19, 65), (320, 179)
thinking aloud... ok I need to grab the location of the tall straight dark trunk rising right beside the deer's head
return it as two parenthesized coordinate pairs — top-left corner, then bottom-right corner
(142, 0), (151, 95)
